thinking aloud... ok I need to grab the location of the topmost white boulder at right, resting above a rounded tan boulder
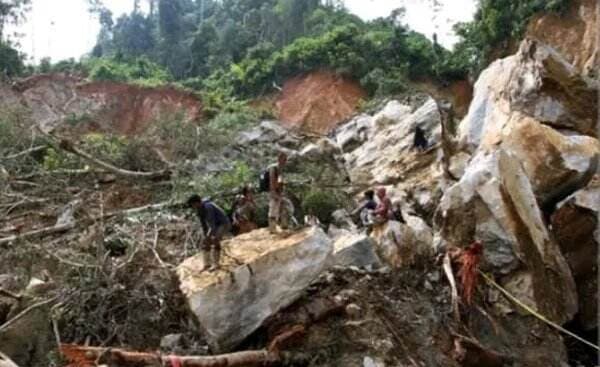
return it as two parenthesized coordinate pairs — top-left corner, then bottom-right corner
(459, 40), (599, 151)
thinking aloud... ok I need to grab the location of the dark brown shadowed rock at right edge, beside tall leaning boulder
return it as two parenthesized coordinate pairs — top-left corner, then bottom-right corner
(552, 176), (600, 329)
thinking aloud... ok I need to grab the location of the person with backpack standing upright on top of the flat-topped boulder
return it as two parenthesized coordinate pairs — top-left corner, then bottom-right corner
(268, 152), (289, 233)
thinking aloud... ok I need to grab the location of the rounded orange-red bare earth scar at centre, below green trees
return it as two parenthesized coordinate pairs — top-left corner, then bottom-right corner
(277, 71), (366, 134)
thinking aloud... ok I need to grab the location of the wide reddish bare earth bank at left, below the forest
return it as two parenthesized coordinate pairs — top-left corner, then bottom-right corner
(8, 74), (202, 134)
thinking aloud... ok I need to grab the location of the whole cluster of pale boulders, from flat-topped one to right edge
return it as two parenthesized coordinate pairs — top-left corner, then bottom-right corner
(173, 8), (600, 357)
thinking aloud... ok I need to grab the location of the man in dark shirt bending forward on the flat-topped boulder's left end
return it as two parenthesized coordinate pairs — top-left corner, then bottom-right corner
(187, 195), (231, 270)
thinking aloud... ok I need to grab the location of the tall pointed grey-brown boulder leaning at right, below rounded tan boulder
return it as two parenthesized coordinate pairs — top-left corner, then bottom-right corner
(435, 149), (577, 322)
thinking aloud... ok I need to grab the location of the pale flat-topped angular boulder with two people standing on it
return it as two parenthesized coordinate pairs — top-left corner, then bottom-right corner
(177, 228), (333, 352)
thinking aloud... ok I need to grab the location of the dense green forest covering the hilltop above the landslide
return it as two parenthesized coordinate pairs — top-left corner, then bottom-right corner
(0, 0), (568, 105)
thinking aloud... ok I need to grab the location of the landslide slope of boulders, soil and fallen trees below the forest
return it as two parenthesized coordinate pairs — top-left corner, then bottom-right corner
(0, 0), (600, 367)
